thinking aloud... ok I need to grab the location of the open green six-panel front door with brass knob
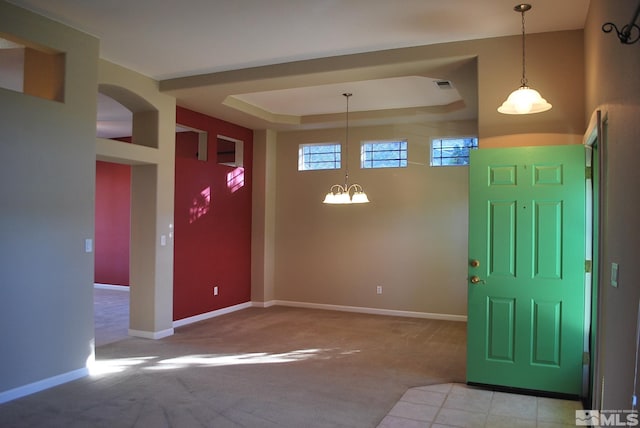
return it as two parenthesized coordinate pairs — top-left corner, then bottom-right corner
(467, 145), (585, 395)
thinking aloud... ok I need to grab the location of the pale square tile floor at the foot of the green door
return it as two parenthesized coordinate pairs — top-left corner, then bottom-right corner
(378, 383), (582, 428)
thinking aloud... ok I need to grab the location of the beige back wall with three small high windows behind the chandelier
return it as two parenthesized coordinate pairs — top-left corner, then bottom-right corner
(275, 121), (477, 315)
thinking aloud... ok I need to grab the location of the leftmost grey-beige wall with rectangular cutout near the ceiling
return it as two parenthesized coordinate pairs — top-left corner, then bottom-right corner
(0, 1), (98, 402)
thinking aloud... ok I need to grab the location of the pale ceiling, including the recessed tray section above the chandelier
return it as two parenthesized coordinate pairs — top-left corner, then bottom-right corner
(9, 0), (589, 136)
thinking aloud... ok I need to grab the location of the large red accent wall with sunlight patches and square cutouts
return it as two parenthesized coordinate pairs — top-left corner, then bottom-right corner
(173, 107), (253, 320)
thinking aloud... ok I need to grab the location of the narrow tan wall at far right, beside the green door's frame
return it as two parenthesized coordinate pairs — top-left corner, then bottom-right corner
(585, 0), (640, 409)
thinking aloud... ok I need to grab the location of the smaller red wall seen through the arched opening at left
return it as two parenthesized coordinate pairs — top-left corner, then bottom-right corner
(94, 161), (131, 285)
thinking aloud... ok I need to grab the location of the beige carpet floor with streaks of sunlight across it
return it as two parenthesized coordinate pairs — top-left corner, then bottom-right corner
(0, 307), (466, 428)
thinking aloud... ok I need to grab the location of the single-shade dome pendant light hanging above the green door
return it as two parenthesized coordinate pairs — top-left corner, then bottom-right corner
(498, 3), (551, 114)
